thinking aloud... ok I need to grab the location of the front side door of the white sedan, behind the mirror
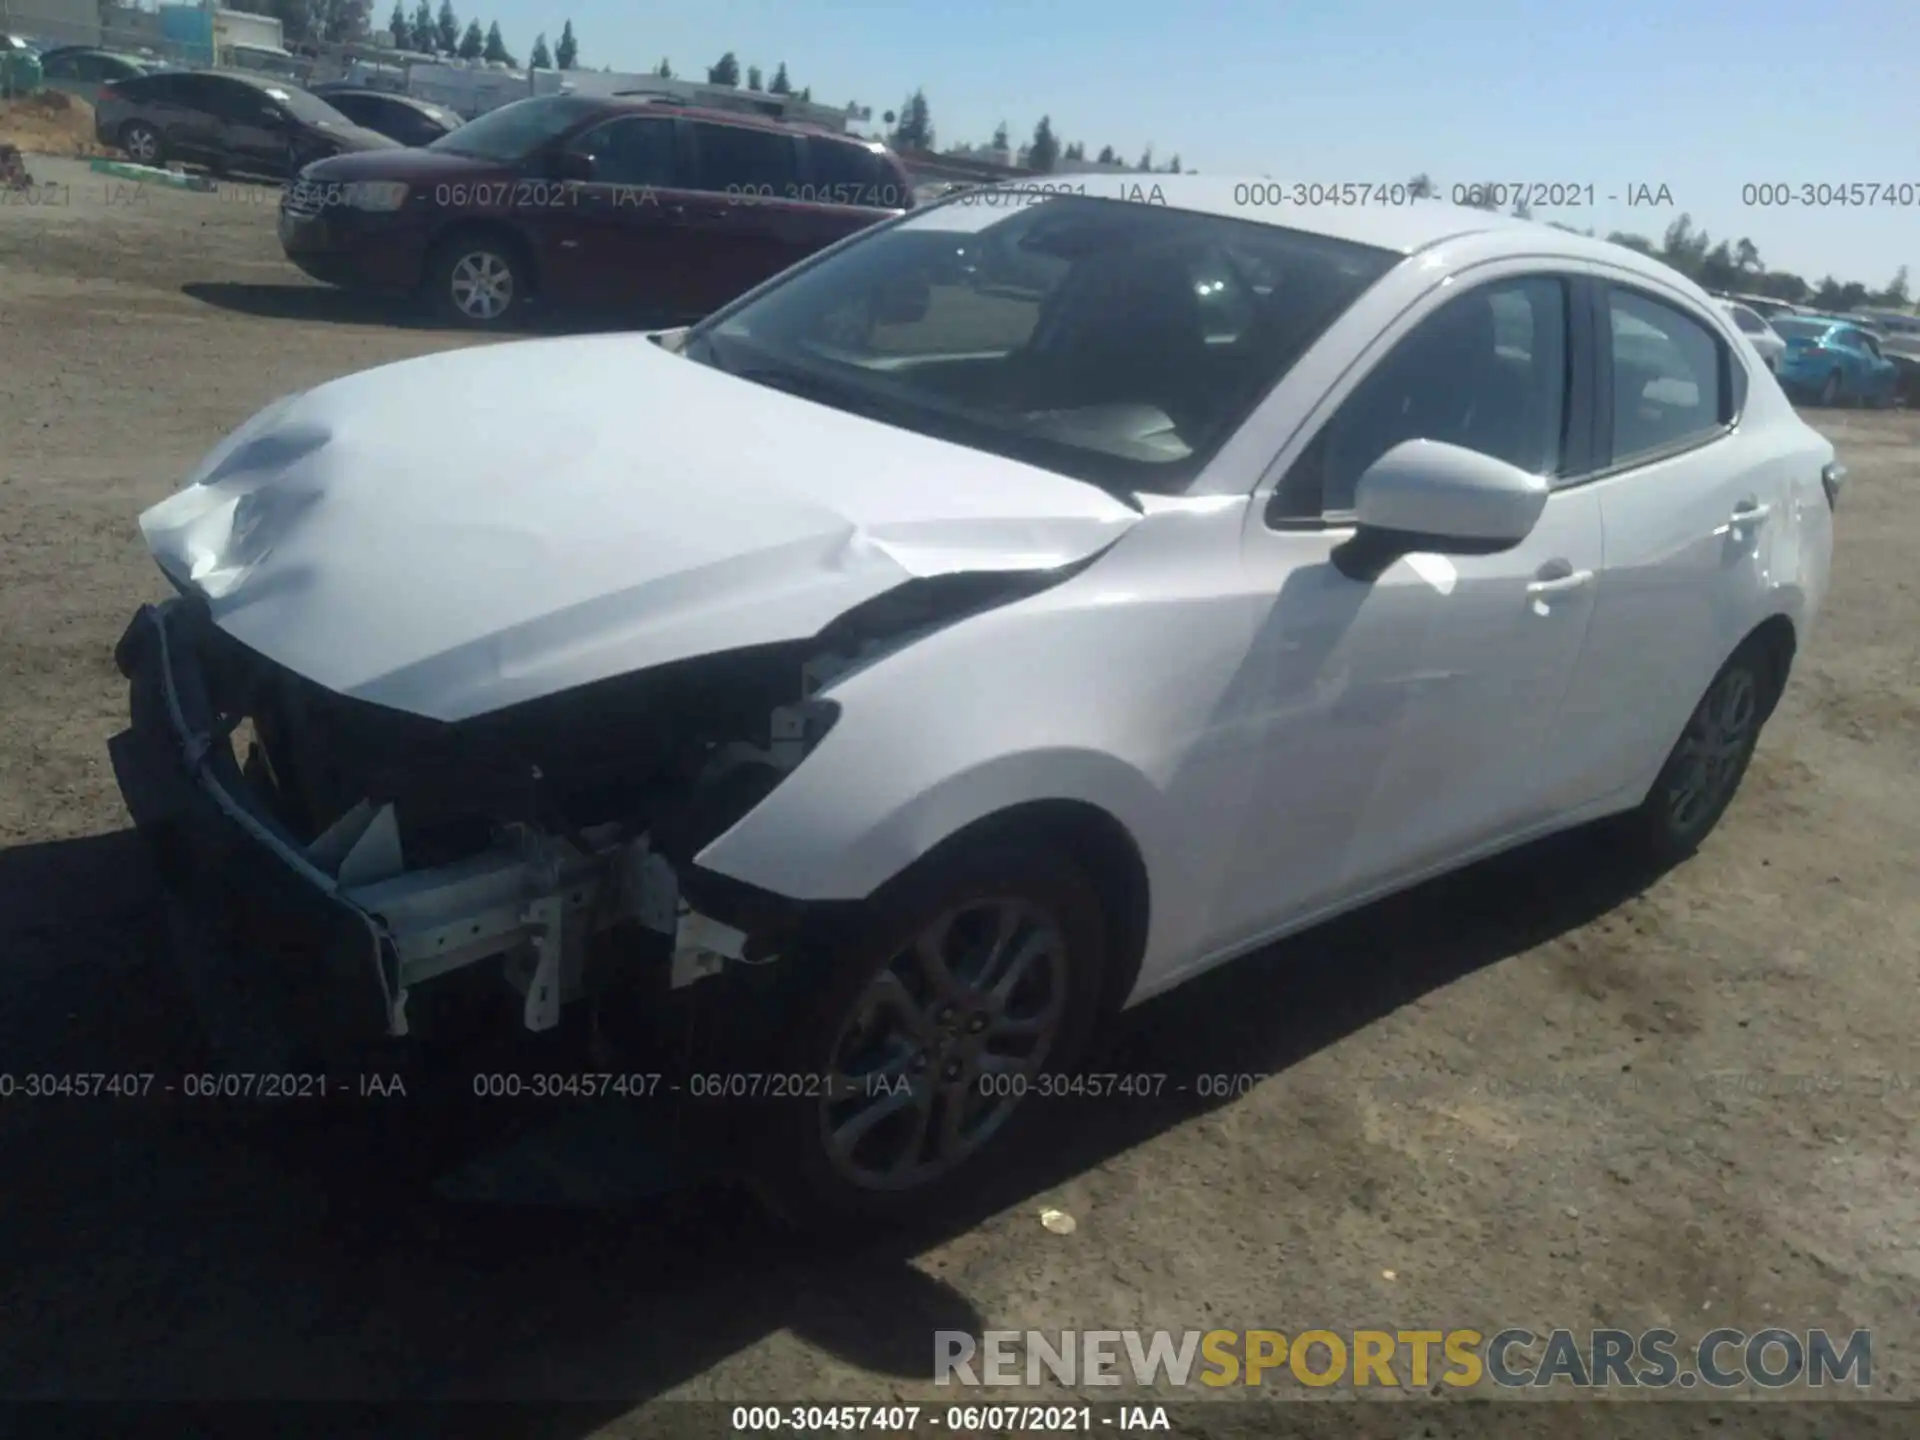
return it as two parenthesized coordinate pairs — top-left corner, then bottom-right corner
(1221, 263), (1605, 948)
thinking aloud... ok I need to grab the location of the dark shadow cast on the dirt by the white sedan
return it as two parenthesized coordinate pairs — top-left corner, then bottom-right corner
(0, 831), (1645, 1413)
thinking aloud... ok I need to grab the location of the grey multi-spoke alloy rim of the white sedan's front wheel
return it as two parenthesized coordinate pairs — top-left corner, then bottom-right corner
(820, 899), (1068, 1190)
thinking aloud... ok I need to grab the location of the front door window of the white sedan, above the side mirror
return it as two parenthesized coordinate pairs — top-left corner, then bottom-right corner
(1273, 276), (1569, 520)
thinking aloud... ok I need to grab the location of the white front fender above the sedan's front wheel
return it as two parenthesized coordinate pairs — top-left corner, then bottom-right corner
(697, 497), (1273, 987)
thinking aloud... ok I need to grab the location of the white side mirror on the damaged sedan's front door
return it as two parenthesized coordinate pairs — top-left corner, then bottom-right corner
(1336, 440), (1548, 578)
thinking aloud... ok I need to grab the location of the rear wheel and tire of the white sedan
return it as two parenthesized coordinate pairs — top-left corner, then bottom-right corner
(1624, 639), (1786, 870)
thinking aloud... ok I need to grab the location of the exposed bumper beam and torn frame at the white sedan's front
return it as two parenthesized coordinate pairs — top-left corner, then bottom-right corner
(109, 599), (747, 1054)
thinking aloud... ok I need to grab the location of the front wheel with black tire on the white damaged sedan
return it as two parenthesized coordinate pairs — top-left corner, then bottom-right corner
(753, 841), (1110, 1231)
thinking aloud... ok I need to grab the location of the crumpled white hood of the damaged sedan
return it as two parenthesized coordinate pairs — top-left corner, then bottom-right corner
(140, 334), (1139, 720)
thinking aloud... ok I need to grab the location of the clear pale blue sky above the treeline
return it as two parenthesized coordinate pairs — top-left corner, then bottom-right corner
(480, 0), (1920, 290)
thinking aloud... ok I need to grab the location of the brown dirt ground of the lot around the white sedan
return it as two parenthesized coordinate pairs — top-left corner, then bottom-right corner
(0, 157), (1920, 1436)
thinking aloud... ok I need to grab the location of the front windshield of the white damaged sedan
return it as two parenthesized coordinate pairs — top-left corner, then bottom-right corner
(684, 192), (1400, 493)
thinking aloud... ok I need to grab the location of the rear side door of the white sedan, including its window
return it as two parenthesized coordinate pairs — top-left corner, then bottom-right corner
(1563, 275), (1789, 806)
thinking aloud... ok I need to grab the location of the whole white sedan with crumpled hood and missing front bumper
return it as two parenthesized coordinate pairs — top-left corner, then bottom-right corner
(111, 177), (1841, 1217)
